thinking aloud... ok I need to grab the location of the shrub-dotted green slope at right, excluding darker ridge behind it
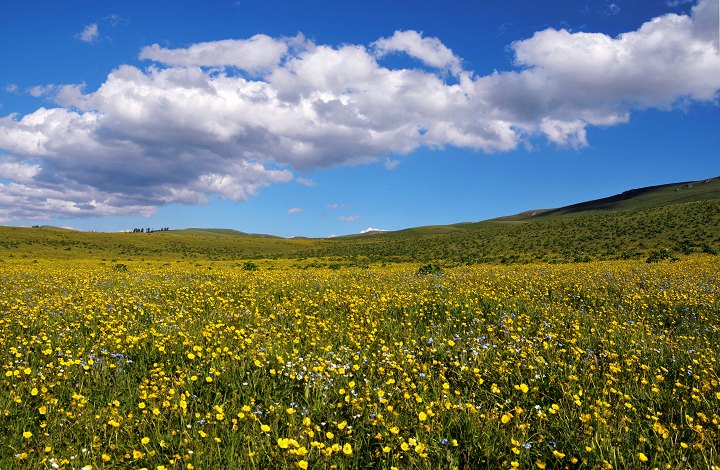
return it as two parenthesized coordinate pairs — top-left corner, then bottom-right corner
(304, 200), (720, 262)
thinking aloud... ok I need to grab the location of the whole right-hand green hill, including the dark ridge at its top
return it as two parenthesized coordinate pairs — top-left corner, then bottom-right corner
(305, 177), (720, 262)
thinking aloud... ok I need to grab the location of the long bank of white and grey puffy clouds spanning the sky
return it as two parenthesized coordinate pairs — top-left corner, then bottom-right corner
(0, 0), (720, 220)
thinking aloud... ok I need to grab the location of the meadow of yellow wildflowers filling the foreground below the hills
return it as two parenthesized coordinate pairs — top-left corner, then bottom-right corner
(0, 255), (720, 469)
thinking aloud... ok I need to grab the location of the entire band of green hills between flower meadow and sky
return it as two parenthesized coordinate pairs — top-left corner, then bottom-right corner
(0, 178), (720, 266)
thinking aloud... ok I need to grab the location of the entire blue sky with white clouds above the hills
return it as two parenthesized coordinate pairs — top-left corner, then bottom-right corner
(0, 0), (720, 237)
